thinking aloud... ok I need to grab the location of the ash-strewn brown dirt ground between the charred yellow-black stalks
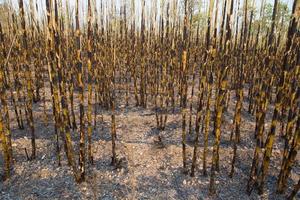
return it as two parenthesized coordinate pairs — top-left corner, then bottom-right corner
(0, 86), (300, 200)
